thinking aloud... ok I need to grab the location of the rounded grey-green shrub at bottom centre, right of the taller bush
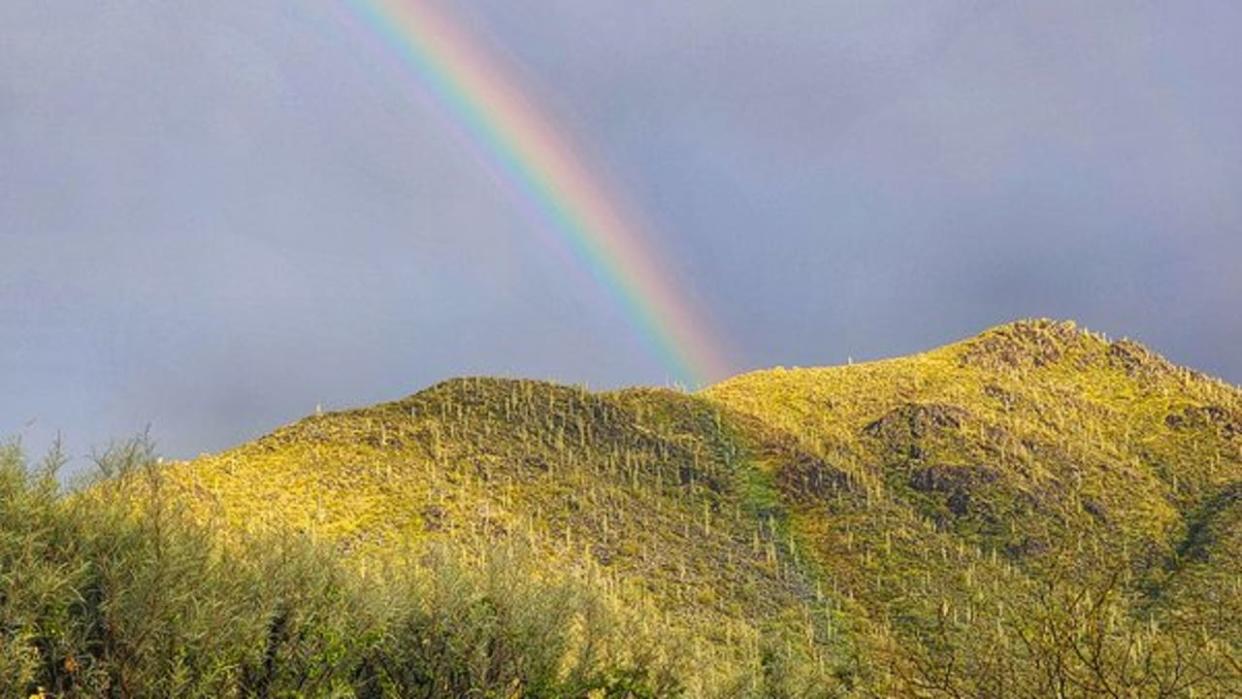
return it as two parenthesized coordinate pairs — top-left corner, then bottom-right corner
(360, 546), (681, 697)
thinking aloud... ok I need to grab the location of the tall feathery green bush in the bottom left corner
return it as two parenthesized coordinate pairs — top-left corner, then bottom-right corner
(0, 441), (366, 697)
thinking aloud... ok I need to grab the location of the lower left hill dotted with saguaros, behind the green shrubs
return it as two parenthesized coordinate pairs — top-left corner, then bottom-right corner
(171, 379), (843, 690)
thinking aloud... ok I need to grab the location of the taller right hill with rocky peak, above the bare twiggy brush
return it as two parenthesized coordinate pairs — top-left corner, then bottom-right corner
(703, 320), (1242, 650)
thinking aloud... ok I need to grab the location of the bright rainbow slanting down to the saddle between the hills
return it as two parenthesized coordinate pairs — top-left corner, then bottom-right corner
(349, 0), (728, 387)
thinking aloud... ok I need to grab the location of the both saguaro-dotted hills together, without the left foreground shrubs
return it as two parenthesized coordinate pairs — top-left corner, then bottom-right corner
(145, 320), (1242, 697)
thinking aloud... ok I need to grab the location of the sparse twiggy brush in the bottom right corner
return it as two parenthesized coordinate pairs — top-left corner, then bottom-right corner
(881, 560), (1242, 698)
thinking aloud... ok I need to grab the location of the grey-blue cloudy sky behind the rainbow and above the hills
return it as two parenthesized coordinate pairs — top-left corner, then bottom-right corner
(0, 0), (1242, 458)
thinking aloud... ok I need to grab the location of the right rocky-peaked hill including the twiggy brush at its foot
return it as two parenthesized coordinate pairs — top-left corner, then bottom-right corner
(704, 322), (1242, 697)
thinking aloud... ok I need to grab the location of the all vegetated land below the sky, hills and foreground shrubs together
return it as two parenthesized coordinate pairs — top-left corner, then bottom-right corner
(0, 320), (1242, 698)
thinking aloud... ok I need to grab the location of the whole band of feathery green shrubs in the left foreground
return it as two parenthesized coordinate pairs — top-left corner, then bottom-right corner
(0, 440), (681, 698)
